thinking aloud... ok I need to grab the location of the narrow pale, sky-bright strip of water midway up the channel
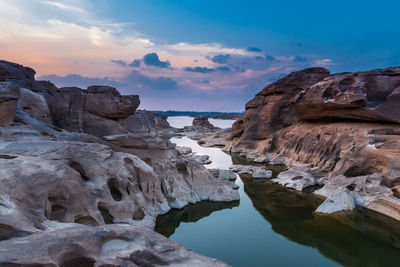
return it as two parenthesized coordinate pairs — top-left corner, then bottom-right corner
(171, 136), (232, 170)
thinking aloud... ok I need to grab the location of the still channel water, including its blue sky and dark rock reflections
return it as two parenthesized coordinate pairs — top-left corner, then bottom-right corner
(156, 117), (400, 267)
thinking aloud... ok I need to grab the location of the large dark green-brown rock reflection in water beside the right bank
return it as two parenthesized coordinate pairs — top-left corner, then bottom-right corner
(243, 179), (400, 267)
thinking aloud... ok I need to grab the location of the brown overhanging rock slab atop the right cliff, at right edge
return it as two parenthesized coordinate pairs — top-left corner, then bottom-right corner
(295, 68), (400, 122)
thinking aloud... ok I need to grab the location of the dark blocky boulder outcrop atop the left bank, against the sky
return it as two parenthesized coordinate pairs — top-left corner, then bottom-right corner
(48, 86), (139, 137)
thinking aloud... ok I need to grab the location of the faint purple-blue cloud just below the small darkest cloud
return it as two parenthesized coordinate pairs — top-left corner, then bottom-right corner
(123, 70), (177, 91)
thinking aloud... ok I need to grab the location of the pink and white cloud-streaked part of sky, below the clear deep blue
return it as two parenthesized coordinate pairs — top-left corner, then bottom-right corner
(0, 0), (334, 111)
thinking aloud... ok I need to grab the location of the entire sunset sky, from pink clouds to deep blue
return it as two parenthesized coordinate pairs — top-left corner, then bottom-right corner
(0, 0), (400, 112)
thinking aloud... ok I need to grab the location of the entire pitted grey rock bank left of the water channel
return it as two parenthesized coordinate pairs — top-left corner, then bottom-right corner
(0, 61), (239, 266)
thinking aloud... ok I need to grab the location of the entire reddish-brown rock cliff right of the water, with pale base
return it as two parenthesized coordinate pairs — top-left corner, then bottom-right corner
(230, 68), (400, 220)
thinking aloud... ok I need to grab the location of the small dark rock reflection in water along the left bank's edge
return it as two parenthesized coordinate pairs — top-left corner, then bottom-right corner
(155, 201), (239, 237)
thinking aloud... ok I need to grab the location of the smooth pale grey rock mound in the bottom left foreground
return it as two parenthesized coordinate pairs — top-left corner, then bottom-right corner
(0, 224), (227, 266)
